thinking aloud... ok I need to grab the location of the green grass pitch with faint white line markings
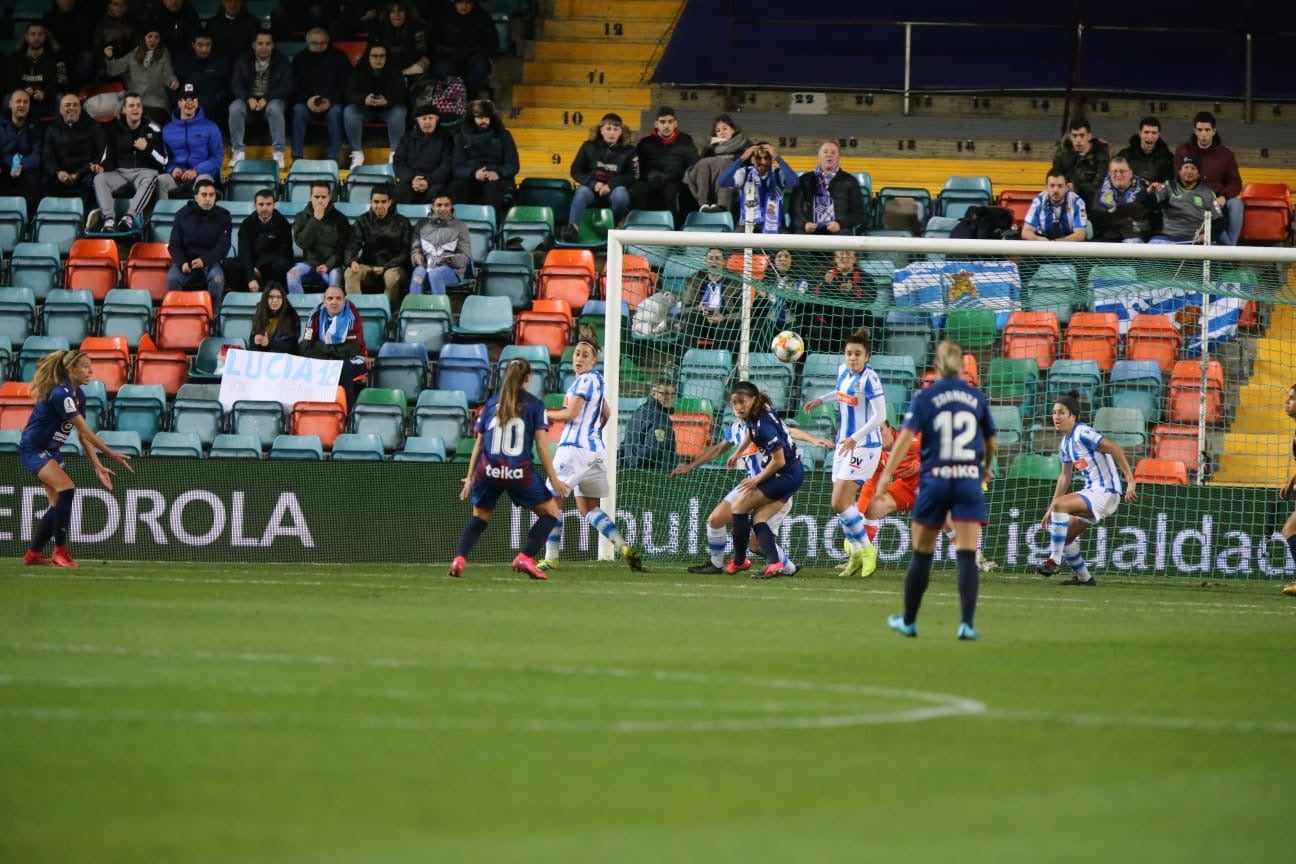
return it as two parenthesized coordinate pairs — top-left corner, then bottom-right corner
(0, 562), (1296, 864)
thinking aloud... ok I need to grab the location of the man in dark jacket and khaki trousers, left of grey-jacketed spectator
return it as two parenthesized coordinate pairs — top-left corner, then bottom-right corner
(342, 184), (413, 310)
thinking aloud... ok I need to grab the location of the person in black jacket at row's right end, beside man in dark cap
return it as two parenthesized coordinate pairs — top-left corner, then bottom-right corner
(450, 98), (521, 225)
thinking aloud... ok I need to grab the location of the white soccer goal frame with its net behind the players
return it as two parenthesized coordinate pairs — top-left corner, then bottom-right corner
(600, 229), (1296, 578)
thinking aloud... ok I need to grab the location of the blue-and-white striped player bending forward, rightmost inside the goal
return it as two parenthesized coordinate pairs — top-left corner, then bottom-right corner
(1037, 390), (1138, 585)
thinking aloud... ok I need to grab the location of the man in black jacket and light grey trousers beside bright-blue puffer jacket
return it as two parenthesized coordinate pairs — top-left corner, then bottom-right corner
(86, 92), (167, 233)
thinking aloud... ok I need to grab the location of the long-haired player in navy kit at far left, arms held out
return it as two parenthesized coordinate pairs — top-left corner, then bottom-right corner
(18, 351), (135, 567)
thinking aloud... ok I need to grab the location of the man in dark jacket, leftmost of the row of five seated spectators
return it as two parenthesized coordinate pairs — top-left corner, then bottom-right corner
(166, 176), (233, 308)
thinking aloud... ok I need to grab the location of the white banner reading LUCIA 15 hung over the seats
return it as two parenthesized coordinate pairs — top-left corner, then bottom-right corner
(220, 348), (342, 411)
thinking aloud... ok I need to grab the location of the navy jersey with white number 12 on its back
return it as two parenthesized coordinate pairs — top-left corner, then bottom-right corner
(903, 377), (995, 478)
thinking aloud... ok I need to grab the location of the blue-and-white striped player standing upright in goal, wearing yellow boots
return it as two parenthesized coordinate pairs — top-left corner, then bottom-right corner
(805, 328), (886, 576)
